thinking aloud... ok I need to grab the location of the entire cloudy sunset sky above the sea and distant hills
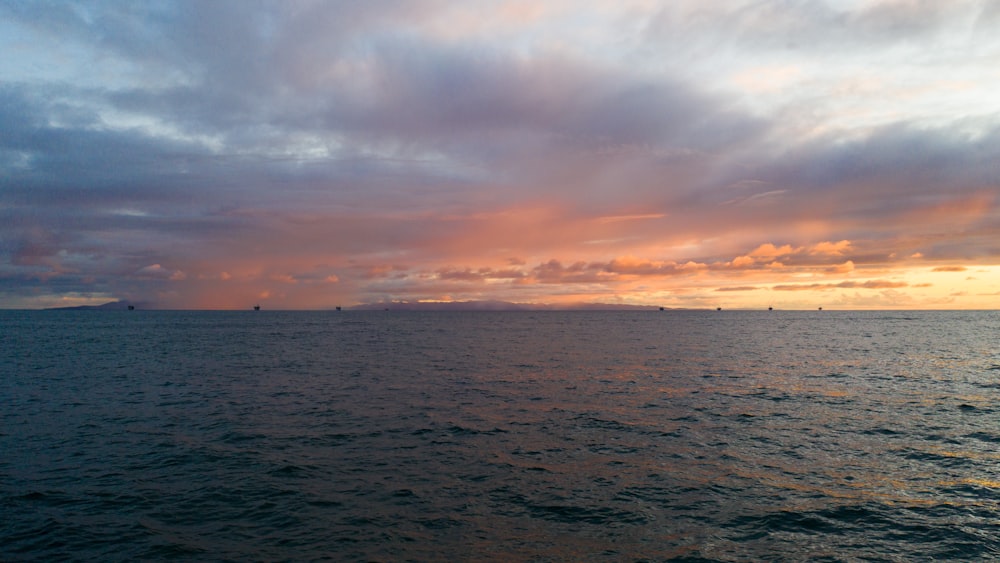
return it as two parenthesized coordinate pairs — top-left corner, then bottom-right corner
(0, 0), (1000, 309)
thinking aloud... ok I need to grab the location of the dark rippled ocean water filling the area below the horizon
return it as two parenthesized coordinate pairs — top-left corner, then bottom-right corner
(0, 311), (1000, 561)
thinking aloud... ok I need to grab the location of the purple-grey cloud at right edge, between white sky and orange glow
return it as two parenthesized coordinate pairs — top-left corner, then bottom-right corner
(688, 123), (1000, 238)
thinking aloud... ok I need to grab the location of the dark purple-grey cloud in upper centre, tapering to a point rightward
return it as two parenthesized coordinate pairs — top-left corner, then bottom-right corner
(304, 38), (761, 158)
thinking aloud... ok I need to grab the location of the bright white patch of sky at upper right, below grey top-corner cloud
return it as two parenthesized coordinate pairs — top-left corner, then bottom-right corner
(624, 2), (1000, 141)
